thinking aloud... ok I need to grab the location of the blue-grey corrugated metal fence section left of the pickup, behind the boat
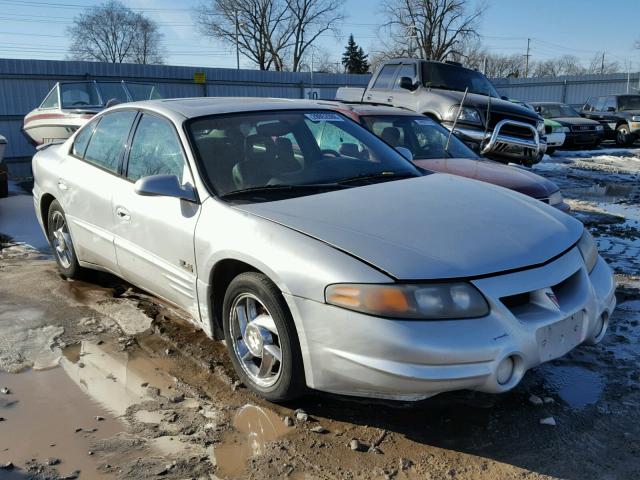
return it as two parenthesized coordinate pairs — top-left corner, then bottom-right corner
(0, 59), (369, 177)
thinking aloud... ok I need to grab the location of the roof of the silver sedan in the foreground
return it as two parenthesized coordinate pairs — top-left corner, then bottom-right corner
(110, 97), (340, 118)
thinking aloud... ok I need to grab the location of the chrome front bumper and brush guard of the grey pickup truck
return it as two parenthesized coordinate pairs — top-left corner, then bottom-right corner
(443, 120), (547, 165)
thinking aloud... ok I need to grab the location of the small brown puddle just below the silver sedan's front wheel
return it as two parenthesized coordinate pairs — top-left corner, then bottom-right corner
(213, 405), (290, 476)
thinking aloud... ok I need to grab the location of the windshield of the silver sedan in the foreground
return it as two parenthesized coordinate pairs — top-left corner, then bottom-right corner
(187, 110), (422, 198)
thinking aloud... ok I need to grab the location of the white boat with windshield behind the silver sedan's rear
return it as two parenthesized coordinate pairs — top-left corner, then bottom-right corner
(22, 80), (162, 146)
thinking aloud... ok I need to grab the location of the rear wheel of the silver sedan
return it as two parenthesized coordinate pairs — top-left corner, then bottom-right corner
(47, 200), (84, 278)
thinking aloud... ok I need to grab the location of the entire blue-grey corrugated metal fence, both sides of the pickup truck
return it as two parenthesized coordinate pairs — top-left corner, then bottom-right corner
(0, 59), (640, 176)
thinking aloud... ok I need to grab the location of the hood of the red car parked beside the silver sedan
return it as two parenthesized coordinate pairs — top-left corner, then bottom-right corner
(413, 158), (559, 199)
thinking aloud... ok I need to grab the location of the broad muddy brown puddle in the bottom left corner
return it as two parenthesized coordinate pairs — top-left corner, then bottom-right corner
(0, 368), (123, 478)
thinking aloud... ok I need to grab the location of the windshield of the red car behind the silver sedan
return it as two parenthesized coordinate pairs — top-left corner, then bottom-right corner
(362, 115), (478, 160)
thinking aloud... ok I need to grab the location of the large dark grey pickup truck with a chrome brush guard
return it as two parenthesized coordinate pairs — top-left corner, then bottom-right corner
(336, 58), (546, 165)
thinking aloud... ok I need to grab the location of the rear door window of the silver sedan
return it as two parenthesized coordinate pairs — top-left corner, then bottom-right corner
(84, 110), (137, 172)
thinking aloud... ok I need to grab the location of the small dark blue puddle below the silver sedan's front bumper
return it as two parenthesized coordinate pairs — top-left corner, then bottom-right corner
(544, 365), (604, 408)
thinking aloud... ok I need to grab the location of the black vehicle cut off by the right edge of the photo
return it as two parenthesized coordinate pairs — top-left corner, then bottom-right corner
(582, 94), (640, 147)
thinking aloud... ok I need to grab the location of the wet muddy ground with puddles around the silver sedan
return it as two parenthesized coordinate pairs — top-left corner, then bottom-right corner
(0, 150), (640, 480)
